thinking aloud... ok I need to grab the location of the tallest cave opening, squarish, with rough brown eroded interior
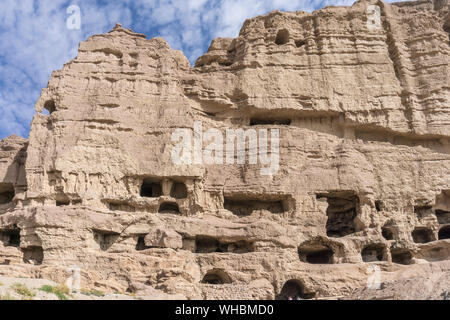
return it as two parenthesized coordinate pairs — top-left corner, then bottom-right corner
(317, 191), (359, 238)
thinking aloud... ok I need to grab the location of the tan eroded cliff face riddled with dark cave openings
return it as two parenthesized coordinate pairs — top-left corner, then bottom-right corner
(0, 0), (450, 299)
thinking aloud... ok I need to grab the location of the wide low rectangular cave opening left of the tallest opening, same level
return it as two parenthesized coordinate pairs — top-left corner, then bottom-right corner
(223, 197), (286, 216)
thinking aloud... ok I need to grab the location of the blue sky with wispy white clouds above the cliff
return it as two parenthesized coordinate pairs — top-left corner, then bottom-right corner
(0, 0), (400, 139)
